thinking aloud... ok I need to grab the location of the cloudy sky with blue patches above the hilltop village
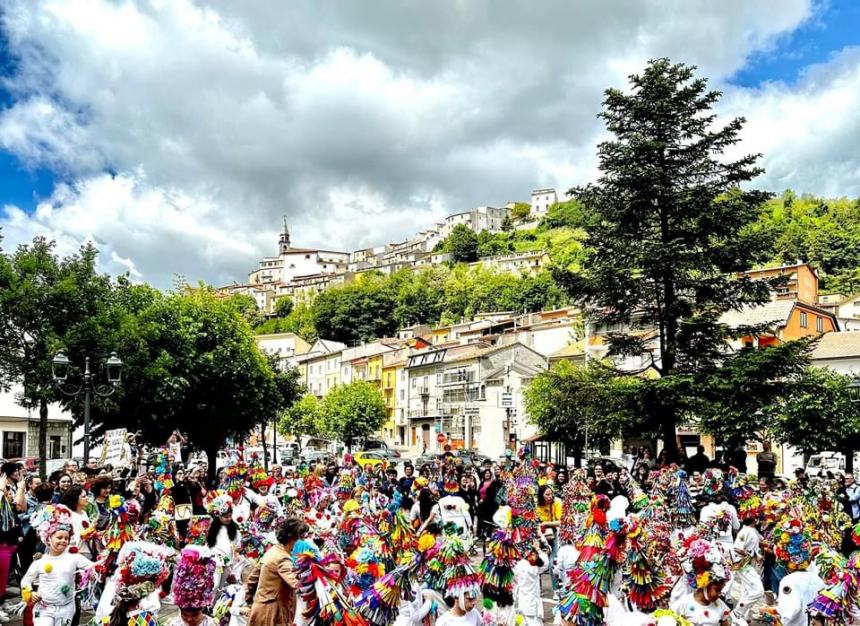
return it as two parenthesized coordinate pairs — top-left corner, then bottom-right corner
(0, 0), (860, 288)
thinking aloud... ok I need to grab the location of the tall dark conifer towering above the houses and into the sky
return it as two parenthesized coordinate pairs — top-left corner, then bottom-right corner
(557, 59), (769, 459)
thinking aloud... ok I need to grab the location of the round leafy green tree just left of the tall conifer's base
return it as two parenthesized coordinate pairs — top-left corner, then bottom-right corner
(525, 361), (640, 467)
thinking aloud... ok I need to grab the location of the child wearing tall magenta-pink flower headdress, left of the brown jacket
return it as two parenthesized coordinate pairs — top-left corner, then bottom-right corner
(167, 546), (216, 626)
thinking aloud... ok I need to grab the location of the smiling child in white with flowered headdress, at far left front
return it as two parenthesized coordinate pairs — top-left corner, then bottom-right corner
(21, 504), (93, 626)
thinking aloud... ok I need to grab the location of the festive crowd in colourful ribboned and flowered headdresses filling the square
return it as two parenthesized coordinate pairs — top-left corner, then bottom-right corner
(0, 438), (860, 626)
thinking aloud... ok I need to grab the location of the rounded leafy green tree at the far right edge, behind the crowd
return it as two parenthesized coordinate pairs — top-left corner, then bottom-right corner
(773, 367), (860, 471)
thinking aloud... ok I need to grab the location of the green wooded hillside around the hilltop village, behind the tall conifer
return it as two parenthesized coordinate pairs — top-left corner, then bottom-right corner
(256, 190), (860, 345)
